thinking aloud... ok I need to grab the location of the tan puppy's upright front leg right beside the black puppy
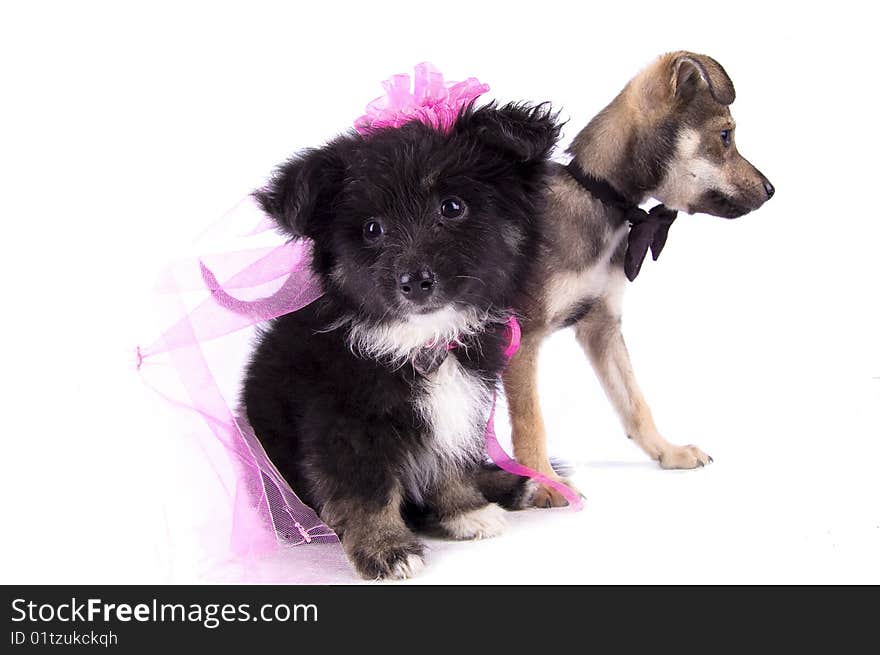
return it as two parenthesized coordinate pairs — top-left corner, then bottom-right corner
(504, 334), (568, 507)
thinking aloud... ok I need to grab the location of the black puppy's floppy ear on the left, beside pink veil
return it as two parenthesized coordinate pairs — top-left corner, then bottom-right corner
(253, 143), (345, 237)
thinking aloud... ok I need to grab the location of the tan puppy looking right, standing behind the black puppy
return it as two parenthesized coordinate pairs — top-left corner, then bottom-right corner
(504, 52), (774, 507)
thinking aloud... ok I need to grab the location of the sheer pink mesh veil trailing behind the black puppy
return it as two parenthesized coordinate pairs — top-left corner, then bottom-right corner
(137, 199), (338, 556)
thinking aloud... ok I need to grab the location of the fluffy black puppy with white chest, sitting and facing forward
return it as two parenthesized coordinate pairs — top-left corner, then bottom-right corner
(243, 105), (558, 578)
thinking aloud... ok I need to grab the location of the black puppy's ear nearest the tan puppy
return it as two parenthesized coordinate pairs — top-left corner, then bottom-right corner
(456, 102), (561, 162)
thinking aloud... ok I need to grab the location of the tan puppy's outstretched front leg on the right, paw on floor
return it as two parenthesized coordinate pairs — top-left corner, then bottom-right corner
(575, 303), (712, 469)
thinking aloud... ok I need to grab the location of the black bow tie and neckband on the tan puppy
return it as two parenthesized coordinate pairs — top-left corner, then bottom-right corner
(566, 161), (678, 282)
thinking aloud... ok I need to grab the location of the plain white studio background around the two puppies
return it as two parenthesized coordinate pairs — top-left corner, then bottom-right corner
(0, 0), (880, 583)
